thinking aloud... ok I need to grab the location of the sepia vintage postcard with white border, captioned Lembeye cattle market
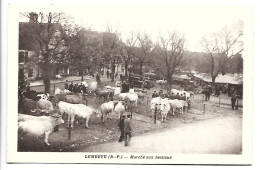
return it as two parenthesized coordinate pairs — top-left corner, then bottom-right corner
(6, 4), (254, 165)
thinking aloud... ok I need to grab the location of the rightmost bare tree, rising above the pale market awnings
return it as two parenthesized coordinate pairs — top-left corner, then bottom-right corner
(202, 22), (243, 83)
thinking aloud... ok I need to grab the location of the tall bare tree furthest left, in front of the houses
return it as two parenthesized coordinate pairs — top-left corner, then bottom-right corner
(20, 12), (70, 93)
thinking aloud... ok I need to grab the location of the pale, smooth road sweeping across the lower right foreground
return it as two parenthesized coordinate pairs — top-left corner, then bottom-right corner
(78, 113), (242, 154)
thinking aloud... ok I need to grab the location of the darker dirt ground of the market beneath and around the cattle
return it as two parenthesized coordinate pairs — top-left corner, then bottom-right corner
(18, 78), (242, 152)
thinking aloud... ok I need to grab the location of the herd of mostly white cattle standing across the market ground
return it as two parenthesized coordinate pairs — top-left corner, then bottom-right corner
(18, 82), (189, 145)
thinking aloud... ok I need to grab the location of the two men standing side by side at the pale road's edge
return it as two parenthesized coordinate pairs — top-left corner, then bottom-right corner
(118, 114), (132, 146)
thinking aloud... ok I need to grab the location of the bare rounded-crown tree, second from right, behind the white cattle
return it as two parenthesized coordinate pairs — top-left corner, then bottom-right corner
(152, 32), (186, 89)
